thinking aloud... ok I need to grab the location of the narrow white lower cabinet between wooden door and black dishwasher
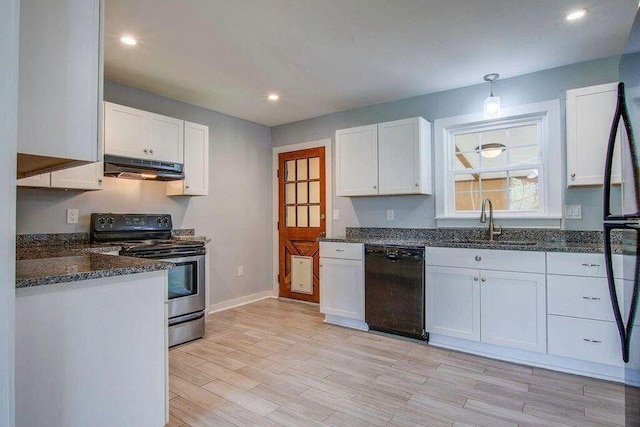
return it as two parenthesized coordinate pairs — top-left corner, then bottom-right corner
(320, 242), (366, 329)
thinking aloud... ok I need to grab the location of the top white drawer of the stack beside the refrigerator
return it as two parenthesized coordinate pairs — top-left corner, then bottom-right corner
(547, 252), (623, 277)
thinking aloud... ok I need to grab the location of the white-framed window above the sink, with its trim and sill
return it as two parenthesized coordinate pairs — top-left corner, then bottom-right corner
(435, 100), (563, 227)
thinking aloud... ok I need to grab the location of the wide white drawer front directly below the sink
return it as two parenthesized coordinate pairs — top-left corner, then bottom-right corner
(426, 248), (545, 273)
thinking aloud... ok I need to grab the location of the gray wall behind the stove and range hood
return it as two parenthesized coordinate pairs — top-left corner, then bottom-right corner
(17, 82), (272, 304)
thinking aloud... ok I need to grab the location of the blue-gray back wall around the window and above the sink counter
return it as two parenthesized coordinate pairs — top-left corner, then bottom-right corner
(271, 57), (619, 236)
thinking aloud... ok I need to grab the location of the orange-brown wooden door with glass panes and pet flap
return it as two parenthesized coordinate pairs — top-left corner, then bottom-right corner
(278, 147), (326, 303)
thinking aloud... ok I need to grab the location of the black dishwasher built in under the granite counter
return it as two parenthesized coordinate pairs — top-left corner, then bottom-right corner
(364, 245), (428, 340)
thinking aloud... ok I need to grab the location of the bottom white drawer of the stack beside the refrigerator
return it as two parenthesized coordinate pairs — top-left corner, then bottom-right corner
(547, 315), (622, 366)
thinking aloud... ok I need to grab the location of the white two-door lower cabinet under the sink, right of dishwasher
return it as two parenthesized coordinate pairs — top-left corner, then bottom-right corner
(426, 248), (547, 352)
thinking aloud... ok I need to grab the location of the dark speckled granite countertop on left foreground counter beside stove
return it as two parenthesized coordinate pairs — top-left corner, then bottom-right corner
(16, 253), (174, 288)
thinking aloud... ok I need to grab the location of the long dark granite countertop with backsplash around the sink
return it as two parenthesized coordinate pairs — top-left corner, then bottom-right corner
(321, 228), (622, 253)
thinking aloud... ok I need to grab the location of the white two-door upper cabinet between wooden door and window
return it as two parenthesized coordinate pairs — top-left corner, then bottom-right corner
(336, 117), (431, 197)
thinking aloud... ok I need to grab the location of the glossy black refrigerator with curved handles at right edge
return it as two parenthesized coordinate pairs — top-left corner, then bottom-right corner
(603, 13), (640, 426)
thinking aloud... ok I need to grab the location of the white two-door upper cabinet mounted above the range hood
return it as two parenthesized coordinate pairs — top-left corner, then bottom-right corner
(104, 102), (184, 163)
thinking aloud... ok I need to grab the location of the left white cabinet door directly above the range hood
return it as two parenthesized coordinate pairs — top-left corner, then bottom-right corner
(104, 102), (150, 159)
